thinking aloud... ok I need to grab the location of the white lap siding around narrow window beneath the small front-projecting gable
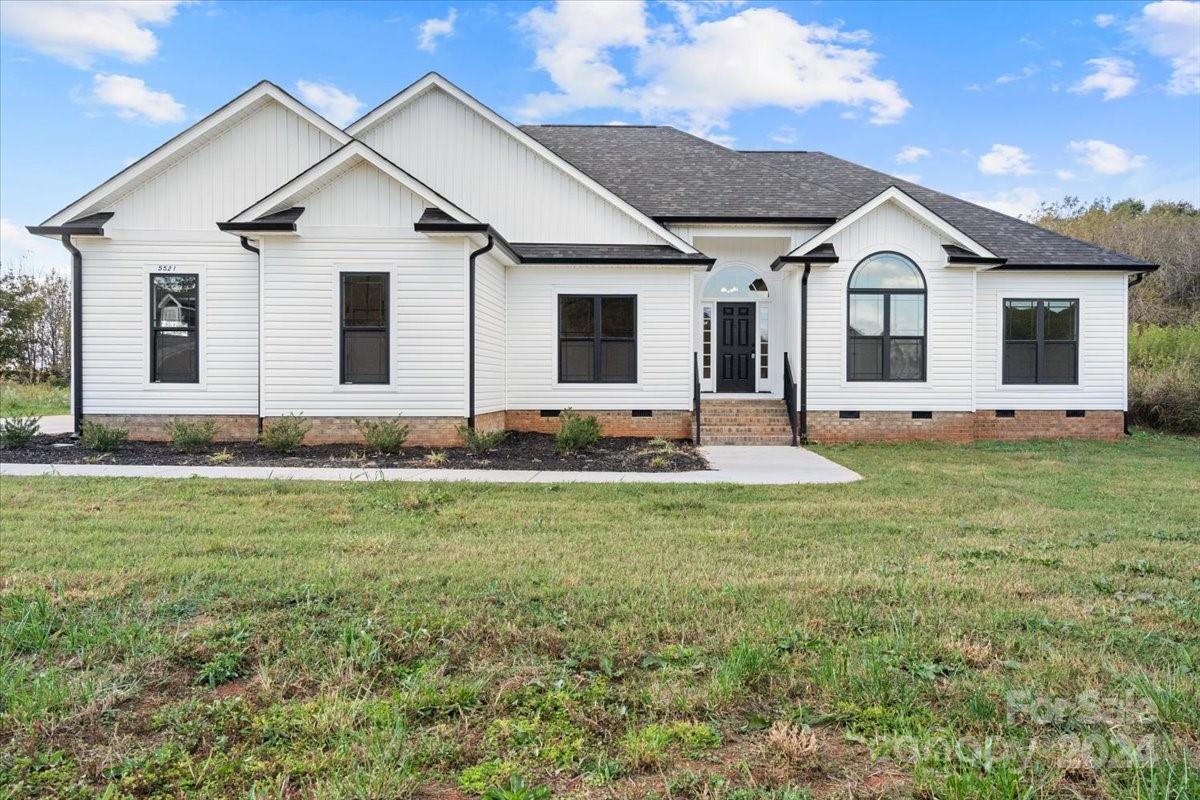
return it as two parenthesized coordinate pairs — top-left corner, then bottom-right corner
(263, 235), (466, 416)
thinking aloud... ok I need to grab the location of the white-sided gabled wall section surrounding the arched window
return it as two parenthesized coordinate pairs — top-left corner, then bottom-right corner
(808, 203), (974, 411)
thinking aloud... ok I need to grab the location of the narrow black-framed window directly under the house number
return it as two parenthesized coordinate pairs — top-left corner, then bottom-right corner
(150, 273), (200, 384)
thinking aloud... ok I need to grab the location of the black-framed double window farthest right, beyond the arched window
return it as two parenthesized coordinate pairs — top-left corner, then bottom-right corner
(1003, 300), (1079, 384)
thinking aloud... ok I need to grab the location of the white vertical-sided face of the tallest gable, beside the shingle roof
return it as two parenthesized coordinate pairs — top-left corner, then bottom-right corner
(347, 78), (690, 249)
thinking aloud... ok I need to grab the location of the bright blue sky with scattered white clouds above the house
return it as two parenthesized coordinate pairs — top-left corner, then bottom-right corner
(0, 0), (1200, 271)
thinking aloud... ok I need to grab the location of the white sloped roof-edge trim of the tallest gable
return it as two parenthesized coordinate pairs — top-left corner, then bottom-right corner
(344, 72), (698, 253)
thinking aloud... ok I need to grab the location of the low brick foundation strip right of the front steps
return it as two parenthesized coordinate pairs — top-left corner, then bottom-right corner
(809, 410), (1124, 444)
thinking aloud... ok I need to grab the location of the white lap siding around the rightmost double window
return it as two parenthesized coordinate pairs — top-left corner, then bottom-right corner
(974, 270), (1128, 410)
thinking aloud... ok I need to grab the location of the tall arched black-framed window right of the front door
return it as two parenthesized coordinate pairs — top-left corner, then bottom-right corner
(846, 253), (925, 380)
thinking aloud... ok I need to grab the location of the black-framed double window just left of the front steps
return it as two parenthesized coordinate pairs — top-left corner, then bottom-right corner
(558, 295), (637, 384)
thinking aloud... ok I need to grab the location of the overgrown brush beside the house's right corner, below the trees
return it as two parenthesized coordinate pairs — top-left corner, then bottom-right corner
(1129, 324), (1200, 433)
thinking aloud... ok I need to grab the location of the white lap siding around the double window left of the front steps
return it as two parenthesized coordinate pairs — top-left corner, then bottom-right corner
(508, 266), (692, 409)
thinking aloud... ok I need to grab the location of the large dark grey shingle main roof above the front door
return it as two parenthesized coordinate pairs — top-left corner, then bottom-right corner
(522, 125), (1150, 269)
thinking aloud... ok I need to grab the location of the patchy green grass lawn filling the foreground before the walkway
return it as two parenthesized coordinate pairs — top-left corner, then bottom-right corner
(0, 434), (1200, 800)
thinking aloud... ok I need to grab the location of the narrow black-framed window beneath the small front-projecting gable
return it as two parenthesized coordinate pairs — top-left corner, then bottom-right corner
(341, 272), (389, 384)
